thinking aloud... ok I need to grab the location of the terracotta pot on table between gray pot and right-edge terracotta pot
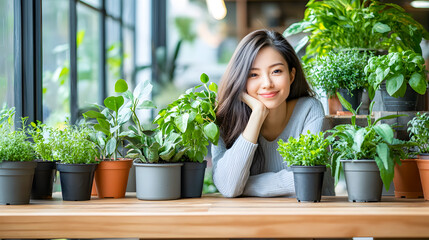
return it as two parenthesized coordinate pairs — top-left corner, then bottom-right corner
(393, 159), (423, 198)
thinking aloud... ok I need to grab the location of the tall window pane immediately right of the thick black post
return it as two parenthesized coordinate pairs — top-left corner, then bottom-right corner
(77, 4), (100, 111)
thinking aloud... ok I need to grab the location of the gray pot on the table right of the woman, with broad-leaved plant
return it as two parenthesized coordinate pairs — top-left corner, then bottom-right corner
(340, 160), (383, 202)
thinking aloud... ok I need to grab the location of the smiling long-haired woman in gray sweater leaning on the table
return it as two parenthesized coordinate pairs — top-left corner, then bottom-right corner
(212, 30), (334, 197)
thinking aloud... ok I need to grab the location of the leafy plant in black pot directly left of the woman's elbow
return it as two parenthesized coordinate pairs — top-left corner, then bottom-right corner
(154, 73), (219, 198)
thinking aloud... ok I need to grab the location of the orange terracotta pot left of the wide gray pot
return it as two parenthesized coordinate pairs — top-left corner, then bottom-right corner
(95, 159), (133, 198)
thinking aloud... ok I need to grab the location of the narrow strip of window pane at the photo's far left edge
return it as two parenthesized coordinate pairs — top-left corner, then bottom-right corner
(0, 0), (14, 109)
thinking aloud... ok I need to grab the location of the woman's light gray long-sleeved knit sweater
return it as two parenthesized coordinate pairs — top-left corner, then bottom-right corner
(212, 97), (335, 197)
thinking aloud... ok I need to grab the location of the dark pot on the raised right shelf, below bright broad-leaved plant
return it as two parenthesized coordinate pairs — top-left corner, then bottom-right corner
(379, 84), (418, 112)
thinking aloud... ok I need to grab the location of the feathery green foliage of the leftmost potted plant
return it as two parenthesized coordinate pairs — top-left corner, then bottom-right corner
(0, 108), (34, 162)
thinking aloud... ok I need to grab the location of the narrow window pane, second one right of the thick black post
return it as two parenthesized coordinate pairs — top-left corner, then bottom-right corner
(106, 18), (121, 96)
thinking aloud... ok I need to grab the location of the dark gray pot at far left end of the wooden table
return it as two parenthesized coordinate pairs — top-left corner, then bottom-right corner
(0, 161), (37, 205)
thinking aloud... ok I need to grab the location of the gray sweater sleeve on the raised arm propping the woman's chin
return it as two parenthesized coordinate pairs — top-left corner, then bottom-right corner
(212, 135), (258, 197)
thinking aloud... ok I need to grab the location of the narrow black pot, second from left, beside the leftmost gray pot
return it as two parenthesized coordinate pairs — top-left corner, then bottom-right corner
(31, 159), (56, 199)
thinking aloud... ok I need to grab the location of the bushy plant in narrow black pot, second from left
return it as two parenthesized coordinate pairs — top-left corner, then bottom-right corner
(28, 121), (56, 199)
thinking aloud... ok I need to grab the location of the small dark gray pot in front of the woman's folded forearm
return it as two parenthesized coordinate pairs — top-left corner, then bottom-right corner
(291, 166), (326, 202)
